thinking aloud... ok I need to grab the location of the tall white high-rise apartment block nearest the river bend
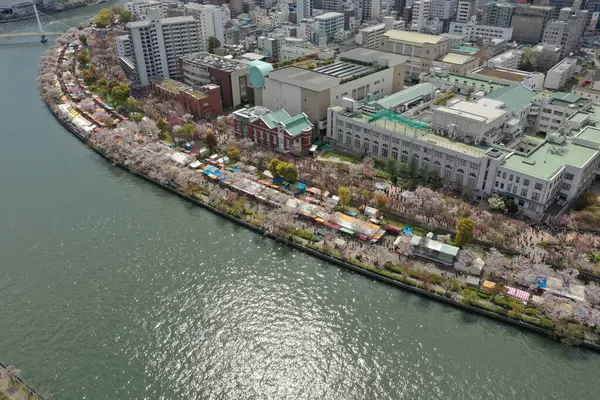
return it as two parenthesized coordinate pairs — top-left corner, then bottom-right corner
(120, 9), (205, 87)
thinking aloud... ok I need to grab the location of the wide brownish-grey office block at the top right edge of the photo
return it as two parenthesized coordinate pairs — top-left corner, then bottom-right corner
(510, 4), (554, 45)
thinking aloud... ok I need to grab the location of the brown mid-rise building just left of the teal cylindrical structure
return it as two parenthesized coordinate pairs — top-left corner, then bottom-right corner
(179, 52), (249, 108)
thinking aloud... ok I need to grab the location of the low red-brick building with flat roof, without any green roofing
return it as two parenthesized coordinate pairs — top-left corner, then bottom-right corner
(150, 77), (223, 118)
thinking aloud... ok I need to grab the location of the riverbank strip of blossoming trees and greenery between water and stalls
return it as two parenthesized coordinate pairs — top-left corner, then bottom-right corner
(38, 24), (598, 349)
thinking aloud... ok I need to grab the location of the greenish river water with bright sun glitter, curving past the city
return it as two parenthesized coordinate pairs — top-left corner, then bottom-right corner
(0, 3), (600, 400)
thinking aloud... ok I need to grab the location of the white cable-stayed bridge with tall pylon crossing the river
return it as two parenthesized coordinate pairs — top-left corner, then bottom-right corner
(0, 3), (71, 43)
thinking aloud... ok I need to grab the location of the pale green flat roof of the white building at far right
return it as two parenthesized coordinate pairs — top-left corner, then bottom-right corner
(504, 140), (598, 179)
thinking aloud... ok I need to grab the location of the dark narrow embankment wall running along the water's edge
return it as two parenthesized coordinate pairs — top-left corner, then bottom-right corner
(47, 104), (600, 352)
